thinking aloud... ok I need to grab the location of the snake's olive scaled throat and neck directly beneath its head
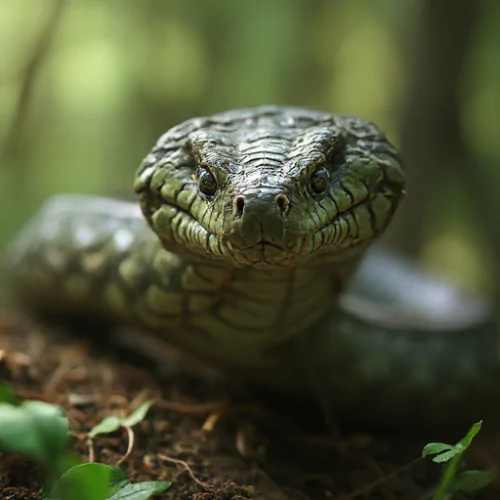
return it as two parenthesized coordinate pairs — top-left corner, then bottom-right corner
(147, 251), (362, 368)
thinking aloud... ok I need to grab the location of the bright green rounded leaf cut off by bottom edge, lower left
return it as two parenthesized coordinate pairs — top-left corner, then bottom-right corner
(45, 462), (130, 500)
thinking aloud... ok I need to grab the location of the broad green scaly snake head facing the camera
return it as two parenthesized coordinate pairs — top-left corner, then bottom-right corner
(134, 106), (404, 266)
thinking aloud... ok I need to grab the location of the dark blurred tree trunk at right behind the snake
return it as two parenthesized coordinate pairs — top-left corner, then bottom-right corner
(389, 0), (500, 292)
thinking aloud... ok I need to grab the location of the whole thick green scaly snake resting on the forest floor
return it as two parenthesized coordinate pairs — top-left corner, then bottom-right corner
(5, 106), (500, 429)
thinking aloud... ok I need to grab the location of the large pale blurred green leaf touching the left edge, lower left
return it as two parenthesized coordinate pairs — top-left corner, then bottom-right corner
(0, 401), (68, 466)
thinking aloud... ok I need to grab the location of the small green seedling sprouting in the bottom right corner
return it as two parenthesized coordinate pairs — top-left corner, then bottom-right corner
(422, 422), (494, 500)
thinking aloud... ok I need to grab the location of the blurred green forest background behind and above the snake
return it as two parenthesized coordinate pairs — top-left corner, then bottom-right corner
(0, 0), (500, 300)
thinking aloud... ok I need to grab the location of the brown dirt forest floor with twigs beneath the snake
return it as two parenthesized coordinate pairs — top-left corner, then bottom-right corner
(0, 311), (500, 500)
